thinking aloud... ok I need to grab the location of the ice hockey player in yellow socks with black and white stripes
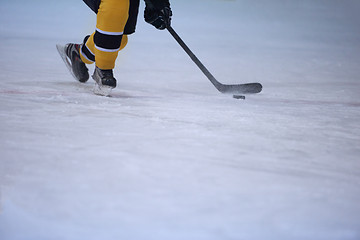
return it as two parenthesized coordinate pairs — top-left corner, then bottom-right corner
(64, 0), (172, 95)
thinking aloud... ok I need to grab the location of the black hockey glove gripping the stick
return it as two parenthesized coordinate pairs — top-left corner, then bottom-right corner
(144, 0), (172, 30)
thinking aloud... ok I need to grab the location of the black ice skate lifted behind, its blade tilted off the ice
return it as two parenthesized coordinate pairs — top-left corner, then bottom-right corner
(56, 43), (89, 83)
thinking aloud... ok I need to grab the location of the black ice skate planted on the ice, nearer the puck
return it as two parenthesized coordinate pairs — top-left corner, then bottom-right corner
(92, 67), (116, 96)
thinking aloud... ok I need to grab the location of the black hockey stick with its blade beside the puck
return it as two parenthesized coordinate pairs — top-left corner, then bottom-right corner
(166, 25), (262, 94)
